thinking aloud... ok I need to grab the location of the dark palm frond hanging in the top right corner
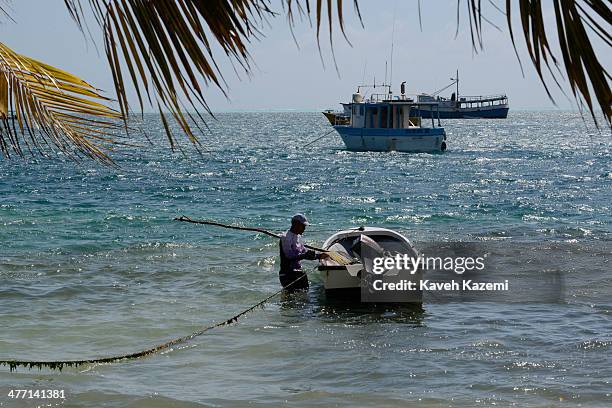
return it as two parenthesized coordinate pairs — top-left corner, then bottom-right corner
(466, 0), (612, 125)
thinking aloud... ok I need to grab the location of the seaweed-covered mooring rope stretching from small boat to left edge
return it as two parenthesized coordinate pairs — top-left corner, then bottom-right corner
(0, 268), (316, 372)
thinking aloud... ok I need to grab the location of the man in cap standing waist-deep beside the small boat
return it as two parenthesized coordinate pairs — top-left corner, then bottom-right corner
(278, 214), (327, 291)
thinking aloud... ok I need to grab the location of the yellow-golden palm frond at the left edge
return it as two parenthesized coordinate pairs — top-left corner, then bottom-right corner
(0, 43), (123, 163)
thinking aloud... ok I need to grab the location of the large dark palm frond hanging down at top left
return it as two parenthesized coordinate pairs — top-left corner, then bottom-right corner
(64, 0), (359, 150)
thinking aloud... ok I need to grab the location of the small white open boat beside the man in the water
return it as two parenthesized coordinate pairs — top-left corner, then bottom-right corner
(318, 227), (422, 303)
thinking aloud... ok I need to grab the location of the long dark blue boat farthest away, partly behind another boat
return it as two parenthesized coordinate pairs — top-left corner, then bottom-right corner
(417, 70), (510, 119)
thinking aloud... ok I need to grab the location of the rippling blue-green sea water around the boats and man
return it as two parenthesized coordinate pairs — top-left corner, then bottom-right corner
(0, 112), (612, 407)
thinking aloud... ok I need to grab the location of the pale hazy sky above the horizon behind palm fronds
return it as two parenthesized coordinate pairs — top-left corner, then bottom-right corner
(0, 0), (612, 111)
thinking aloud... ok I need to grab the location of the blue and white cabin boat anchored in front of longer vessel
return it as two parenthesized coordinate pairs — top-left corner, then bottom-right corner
(326, 83), (447, 153)
